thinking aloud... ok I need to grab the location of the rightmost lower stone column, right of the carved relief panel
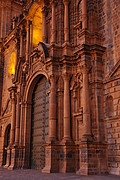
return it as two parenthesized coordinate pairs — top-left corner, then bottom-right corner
(82, 65), (91, 135)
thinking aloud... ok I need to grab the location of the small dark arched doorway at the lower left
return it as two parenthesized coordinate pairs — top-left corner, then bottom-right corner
(3, 124), (11, 165)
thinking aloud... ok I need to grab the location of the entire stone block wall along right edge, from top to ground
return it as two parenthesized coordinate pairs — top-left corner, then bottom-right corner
(98, 0), (120, 175)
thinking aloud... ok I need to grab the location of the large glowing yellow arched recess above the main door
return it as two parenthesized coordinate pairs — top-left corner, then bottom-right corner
(33, 8), (42, 46)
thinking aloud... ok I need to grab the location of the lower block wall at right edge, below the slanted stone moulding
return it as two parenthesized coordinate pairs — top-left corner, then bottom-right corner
(104, 79), (120, 175)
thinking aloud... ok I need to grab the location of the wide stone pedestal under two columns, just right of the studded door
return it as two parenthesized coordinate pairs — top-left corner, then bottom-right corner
(42, 139), (76, 173)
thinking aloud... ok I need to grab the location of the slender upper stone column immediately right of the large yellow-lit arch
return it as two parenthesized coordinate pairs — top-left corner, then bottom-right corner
(42, 7), (46, 42)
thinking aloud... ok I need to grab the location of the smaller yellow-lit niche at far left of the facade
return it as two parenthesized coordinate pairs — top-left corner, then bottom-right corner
(8, 52), (16, 76)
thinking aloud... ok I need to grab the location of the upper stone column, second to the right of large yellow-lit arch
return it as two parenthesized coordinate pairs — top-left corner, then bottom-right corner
(51, 0), (56, 43)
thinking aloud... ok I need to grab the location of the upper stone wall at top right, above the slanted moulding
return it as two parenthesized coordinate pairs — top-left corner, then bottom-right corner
(98, 0), (120, 74)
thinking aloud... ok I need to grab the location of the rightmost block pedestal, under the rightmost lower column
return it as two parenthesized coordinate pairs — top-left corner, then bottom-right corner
(76, 139), (107, 175)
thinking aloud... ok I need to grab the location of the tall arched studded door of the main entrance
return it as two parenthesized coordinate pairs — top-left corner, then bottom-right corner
(30, 76), (49, 170)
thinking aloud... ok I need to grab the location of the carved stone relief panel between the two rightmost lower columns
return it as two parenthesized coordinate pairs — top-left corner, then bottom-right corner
(70, 73), (83, 141)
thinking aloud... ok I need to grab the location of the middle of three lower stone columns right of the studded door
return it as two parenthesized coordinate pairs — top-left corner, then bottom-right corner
(63, 74), (70, 140)
